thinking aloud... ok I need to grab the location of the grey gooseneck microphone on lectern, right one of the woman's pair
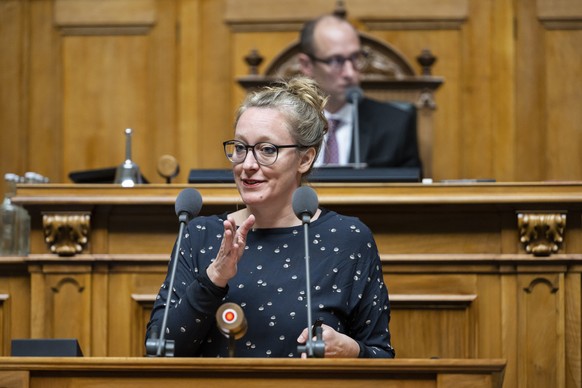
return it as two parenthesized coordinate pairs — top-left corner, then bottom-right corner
(292, 186), (325, 358)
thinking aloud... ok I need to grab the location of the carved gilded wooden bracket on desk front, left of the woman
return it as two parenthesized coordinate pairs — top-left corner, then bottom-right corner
(42, 212), (91, 256)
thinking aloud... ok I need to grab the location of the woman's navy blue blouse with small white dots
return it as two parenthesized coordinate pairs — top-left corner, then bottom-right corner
(148, 211), (394, 358)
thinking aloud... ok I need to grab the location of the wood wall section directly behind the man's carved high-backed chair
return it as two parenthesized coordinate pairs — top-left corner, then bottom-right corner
(226, 0), (468, 179)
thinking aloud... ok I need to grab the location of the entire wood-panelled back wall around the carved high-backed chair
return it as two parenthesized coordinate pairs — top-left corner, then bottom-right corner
(0, 0), (582, 182)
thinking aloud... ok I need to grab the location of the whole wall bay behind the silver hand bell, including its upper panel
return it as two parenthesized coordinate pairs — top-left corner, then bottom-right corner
(20, 0), (177, 181)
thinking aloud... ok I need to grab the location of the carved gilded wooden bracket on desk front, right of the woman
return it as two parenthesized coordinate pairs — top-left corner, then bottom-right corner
(517, 213), (566, 256)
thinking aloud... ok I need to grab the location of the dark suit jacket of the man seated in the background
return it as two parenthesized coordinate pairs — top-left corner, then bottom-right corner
(350, 98), (422, 168)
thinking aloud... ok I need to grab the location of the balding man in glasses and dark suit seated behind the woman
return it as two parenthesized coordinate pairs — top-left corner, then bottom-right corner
(299, 15), (421, 168)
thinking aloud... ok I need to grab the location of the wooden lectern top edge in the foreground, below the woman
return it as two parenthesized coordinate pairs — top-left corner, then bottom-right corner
(0, 357), (505, 388)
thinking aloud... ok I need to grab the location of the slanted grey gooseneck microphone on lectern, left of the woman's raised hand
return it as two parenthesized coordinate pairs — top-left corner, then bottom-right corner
(146, 188), (202, 357)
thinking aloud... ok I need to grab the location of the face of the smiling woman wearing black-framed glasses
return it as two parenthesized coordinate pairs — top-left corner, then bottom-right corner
(233, 108), (315, 209)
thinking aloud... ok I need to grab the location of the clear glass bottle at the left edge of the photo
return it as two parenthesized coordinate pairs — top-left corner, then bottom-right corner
(0, 174), (30, 256)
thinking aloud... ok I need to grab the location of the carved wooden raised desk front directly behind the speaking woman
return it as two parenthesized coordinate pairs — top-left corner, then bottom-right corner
(0, 182), (582, 388)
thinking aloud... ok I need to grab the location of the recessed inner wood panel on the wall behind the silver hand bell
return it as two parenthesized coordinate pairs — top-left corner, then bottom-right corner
(62, 35), (155, 172)
